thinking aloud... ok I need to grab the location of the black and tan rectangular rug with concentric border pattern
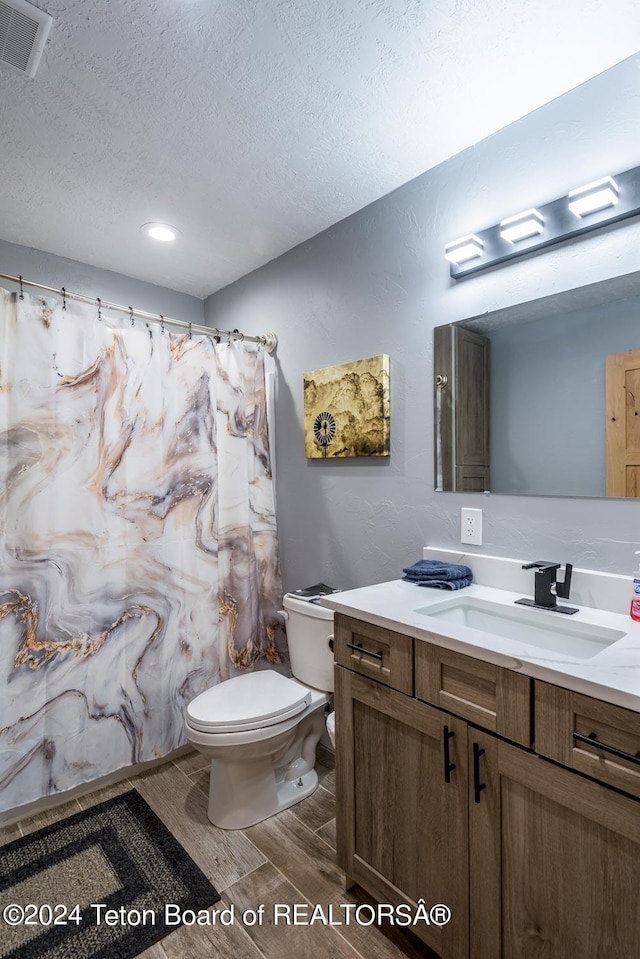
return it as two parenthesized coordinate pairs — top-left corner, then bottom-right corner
(0, 789), (220, 959)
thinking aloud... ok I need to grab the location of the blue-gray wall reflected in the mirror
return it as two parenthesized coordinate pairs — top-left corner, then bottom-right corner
(489, 297), (640, 496)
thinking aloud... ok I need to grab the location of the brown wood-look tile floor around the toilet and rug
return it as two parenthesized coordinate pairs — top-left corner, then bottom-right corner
(0, 746), (437, 959)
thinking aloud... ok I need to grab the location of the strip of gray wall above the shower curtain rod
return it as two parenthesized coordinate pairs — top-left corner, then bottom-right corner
(0, 240), (204, 323)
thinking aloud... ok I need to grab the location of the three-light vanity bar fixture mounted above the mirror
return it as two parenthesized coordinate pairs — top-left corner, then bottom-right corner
(445, 166), (640, 280)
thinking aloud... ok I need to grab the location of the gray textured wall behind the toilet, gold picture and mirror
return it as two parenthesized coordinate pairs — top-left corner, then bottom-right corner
(205, 56), (640, 589)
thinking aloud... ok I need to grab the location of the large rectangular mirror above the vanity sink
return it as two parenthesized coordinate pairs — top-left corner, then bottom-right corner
(434, 273), (640, 497)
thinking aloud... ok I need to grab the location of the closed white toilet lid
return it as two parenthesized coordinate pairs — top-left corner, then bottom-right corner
(187, 669), (311, 733)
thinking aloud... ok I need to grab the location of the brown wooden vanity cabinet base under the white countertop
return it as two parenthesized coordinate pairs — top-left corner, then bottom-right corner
(335, 614), (640, 959)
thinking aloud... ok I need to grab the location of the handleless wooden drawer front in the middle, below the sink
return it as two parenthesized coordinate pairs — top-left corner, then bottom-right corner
(415, 640), (532, 747)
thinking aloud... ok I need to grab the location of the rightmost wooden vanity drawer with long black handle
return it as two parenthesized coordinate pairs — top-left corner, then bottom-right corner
(535, 680), (640, 796)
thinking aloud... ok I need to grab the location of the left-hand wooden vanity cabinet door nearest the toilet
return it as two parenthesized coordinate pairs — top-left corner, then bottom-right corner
(335, 666), (468, 959)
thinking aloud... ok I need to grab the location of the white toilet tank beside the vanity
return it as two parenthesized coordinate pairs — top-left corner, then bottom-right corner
(282, 593), (333, 693)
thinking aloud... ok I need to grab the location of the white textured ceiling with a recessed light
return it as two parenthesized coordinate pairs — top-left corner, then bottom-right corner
(0, 0), (640, 297)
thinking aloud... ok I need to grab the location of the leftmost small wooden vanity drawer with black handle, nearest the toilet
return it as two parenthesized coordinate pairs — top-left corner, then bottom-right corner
(334, 613), (413, 696)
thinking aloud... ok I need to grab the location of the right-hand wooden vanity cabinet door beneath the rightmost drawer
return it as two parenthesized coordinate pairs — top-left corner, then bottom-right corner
(469, 729), (640, 959)
